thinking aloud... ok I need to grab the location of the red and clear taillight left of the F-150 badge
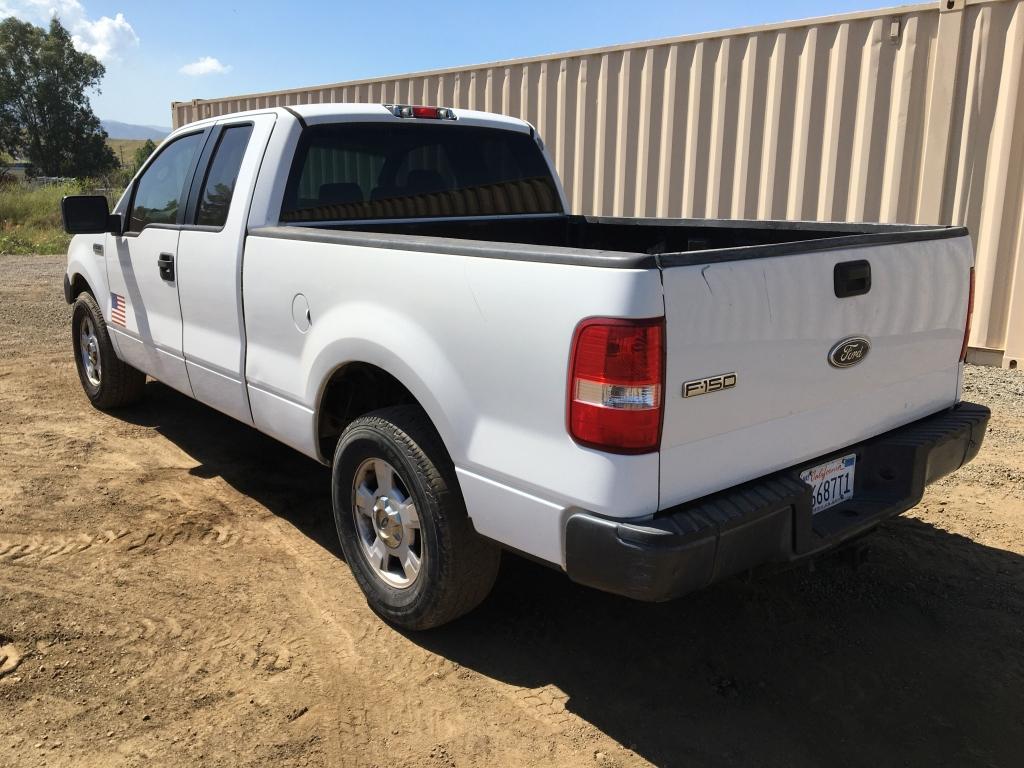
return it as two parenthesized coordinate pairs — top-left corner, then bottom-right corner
(568, 317), (665, 454)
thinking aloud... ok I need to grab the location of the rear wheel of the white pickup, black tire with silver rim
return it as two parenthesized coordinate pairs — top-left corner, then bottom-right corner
(331, 406), (501, 630)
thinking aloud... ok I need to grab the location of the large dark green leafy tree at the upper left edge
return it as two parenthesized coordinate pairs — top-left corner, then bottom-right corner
(0, 16), (118, 176)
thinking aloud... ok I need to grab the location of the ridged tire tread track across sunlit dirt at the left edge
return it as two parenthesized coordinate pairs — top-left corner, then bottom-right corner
(0, 521), (248, 564)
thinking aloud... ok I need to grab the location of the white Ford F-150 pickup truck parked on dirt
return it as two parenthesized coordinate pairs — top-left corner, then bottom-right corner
(62, 104), (989, 629)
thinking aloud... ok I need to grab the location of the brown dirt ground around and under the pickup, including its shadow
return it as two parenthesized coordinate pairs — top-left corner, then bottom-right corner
(0, 257), (1024, 768)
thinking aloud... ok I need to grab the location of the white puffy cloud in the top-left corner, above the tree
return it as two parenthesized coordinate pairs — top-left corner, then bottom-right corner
(0, 0), (138, 63)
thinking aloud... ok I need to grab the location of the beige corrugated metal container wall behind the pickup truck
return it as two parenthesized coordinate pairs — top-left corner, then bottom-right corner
(172, 0), (1024, 365)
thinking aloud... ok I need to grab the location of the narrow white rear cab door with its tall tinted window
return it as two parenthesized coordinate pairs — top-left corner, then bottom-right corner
(177, 114), (276, 424)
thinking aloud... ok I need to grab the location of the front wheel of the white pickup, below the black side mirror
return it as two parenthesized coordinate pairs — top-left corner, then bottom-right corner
(71, 293), (145, 411)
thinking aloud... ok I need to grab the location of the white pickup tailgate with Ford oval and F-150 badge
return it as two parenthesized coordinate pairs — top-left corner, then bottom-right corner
(659, 229), (973, 509)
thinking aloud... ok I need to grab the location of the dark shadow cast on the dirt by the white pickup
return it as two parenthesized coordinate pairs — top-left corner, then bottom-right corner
(119, 383), (1024, 766)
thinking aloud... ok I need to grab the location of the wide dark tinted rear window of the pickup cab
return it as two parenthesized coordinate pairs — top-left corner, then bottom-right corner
(281, 122), (562, 222)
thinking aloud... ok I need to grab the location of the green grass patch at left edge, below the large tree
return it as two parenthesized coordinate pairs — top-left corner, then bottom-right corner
(0, 183), (82, 254)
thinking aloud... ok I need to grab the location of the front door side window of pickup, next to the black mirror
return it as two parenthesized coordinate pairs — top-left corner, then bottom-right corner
(128, 133), (203, 232)
